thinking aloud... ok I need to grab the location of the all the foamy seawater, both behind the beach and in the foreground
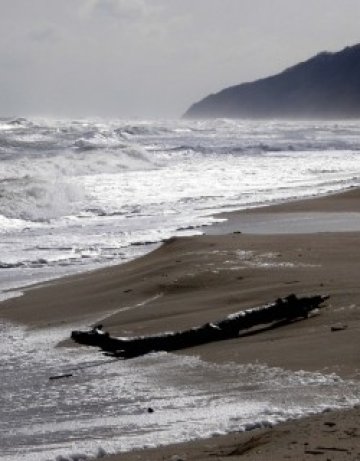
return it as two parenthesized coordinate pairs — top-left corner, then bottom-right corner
(0, 118), (360, 461)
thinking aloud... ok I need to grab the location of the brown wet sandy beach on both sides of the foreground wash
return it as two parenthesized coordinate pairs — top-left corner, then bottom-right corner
(0, 189), (360, 461)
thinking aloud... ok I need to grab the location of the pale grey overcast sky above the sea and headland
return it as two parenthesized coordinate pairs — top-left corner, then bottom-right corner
(0, 0), (360, 118)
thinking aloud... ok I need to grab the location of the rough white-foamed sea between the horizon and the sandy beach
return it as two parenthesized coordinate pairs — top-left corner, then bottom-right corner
(0, 118), (360, 300)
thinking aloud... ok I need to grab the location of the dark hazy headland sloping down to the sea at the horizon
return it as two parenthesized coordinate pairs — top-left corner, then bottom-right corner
(184, 44), (360, 119)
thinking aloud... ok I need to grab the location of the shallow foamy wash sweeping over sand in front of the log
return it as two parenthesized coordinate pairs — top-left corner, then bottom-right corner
(0, 319), (360, 461)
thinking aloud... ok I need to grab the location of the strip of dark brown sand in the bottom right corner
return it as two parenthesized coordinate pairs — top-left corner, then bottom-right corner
(106, 407), (360, 461)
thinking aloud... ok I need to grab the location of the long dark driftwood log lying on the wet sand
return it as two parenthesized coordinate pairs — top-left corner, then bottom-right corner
(71, 295), (328, 359)
